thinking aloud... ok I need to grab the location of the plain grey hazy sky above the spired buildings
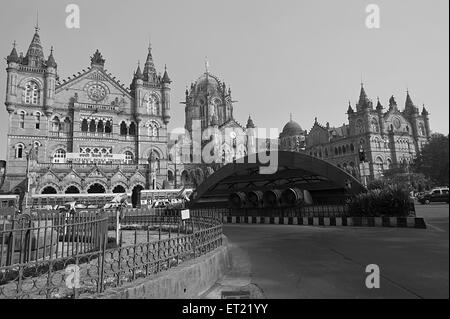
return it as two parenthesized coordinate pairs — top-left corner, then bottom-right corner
(0, 0), (449, 158)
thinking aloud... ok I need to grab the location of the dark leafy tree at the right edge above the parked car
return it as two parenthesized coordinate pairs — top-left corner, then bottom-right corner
(412, 134), (449, 186)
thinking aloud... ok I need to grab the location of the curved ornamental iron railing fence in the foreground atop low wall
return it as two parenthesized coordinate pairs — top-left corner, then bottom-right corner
(0, 210), (222, 298)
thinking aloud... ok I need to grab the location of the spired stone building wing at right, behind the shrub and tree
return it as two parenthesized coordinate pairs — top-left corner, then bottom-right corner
(305, 86), (431, 179)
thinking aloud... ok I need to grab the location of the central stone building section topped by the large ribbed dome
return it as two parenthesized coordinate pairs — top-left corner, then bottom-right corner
(168, 69), (257, 187)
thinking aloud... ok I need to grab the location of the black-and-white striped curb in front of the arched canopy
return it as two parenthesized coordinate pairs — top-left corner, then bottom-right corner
(223, 216), (427, 229)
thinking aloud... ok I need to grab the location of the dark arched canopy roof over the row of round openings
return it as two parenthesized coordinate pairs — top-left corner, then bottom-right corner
(191, 151), (366, 206)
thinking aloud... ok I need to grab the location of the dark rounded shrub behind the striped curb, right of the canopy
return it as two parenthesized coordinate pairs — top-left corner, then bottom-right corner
(349, 185), (410, 217)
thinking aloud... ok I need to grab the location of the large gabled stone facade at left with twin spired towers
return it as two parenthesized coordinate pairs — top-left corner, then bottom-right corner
(3, 28), (171, 198)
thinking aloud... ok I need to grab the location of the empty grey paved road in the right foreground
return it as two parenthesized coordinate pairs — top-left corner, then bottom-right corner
(203, 204), (449, 299)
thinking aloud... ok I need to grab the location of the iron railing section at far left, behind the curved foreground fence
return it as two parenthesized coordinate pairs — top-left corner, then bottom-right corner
(0, 211), (107, 267)
